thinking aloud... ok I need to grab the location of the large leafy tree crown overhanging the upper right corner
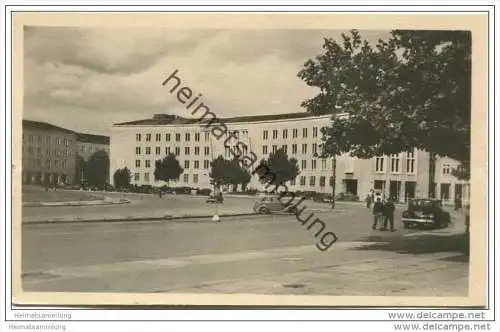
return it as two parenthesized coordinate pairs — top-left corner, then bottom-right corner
(298, 30), (471, 177)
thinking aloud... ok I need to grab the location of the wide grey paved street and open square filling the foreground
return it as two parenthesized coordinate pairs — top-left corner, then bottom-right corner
(22, 197), (468, 296)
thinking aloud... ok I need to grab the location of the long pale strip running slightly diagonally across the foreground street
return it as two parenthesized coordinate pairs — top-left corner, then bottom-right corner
(23, 242), (376, 284)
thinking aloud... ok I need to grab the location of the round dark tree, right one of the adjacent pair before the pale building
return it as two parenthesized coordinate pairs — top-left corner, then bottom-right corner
(256, 149), (300, 187)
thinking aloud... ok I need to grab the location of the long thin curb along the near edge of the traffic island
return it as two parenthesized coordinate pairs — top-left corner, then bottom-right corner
(22, 212), (259, 225)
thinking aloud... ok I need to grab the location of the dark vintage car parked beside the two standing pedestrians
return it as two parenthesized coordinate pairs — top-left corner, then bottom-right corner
(401, 199), (451, 228)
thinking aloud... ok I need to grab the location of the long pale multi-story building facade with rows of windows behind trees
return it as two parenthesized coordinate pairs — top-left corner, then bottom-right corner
(110, 112), (468, 201)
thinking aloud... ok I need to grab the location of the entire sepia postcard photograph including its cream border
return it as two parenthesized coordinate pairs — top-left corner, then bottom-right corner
(12, 13), (487, 305)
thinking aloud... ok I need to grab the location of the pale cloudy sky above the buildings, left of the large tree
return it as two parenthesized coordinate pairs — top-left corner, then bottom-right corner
(23, 26), (389, 135)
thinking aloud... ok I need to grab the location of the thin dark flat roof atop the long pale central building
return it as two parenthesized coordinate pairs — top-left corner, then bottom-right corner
(113, 112), (333, 126)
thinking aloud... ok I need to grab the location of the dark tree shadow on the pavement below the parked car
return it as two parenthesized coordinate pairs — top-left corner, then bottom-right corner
(353, 233), (469, 261)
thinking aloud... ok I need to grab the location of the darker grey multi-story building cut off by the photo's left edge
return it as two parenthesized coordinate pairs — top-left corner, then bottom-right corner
(22, 120), (77, 185)
